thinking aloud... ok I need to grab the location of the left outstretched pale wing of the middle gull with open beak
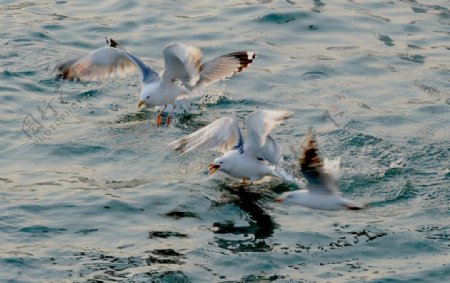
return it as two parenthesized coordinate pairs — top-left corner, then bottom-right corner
(170, 117), (244, 153)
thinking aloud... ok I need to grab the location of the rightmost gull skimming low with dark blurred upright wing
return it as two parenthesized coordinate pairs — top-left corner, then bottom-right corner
(275, 129), (366, 210)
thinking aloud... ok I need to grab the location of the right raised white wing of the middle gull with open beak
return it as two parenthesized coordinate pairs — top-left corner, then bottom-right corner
(244, 110), (292, 165)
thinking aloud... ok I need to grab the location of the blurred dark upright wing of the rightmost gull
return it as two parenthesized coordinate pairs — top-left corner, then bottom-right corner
(299, 131), (339, 194)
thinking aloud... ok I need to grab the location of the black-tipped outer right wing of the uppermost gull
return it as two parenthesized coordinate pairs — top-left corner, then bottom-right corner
(196, 51), (256, 87)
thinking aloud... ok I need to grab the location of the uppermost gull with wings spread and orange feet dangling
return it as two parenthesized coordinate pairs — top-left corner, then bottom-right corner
(55, 38), (256, 126)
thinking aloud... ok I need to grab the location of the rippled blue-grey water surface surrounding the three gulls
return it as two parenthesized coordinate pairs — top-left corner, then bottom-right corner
(0, 0), (450, 282)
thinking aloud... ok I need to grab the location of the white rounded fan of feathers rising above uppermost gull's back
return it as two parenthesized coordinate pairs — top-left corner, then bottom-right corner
(163, 43), (202, 88)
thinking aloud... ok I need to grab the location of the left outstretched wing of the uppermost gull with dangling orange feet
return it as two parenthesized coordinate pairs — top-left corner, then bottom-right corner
(55, 40), (158, 82)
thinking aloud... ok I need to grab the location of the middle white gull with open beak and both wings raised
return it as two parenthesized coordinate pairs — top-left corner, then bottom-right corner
(170, 110), (292, 184)
